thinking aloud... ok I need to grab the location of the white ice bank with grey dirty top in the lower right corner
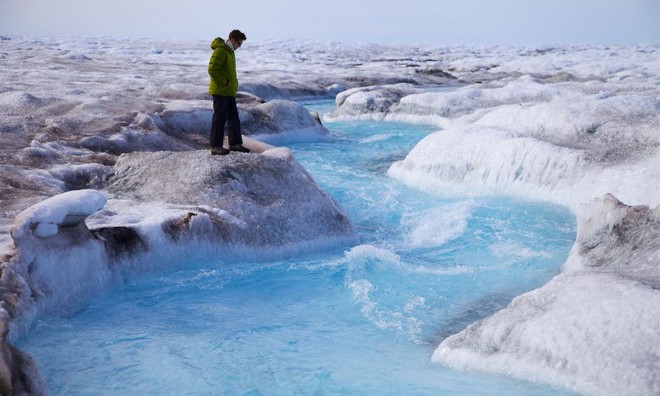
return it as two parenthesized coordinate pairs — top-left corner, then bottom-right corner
(432, 195), (660, 395)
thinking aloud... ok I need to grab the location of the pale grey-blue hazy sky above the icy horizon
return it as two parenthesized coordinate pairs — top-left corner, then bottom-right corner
(0, 0), (660, 45)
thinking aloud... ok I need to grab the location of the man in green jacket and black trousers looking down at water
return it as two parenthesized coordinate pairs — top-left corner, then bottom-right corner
(209, 30), (250, 155)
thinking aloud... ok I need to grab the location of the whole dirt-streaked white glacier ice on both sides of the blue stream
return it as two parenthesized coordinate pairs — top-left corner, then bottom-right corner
(0, 37), (660, 395)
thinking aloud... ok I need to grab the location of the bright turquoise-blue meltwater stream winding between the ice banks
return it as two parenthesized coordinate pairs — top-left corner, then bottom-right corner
(12, 101), (575, 395)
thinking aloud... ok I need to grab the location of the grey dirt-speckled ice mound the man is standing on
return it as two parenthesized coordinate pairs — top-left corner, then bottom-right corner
(106, 148), (354, 256)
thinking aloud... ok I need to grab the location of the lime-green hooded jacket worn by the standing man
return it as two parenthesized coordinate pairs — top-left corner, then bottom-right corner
(209, 37), (238, 96)
